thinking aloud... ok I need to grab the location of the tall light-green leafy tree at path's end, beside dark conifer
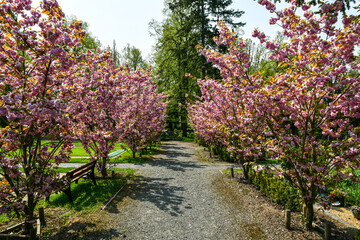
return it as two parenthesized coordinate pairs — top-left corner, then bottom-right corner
(153, 1), (201, 136)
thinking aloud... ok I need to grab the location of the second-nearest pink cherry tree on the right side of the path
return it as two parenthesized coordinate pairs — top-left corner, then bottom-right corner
(188, 22), (264, 178)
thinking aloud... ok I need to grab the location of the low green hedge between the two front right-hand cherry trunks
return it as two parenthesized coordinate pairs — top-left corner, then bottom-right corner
(249, 169), (301, 210)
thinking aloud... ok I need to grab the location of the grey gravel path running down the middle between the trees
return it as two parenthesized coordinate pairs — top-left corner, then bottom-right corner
(97, 142), (245, 240)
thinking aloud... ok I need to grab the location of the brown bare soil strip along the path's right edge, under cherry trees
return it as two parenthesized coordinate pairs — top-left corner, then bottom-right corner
(215, 174), (356, 240)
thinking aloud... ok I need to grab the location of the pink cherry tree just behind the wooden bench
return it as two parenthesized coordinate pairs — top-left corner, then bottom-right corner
(69, 51), (122, 177)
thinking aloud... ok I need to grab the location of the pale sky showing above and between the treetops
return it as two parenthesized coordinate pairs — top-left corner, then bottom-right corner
(33, 0), (292, 58)
